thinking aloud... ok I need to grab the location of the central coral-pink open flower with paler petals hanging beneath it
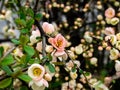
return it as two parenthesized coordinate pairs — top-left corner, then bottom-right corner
(48, 34), (67, 55)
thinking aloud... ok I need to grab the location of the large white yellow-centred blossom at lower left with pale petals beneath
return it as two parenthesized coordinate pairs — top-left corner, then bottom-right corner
(28, 64), (48, 87)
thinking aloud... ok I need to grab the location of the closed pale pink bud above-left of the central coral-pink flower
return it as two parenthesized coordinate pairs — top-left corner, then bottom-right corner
(42, 22), (55, 34)
